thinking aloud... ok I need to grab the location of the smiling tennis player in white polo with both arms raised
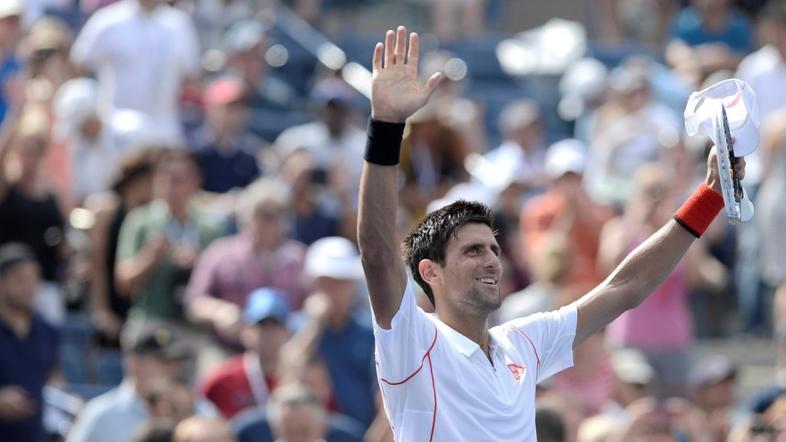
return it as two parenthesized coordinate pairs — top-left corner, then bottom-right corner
(358, 27), (745, 442)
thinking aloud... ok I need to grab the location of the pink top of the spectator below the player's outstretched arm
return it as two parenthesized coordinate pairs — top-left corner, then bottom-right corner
(606, 265), (693, 350)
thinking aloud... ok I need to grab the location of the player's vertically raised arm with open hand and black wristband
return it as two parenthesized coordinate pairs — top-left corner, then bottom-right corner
(358, 26), (440, 328)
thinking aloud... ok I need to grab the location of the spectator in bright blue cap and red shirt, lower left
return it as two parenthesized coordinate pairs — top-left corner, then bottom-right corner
(200, 288), (289, 419)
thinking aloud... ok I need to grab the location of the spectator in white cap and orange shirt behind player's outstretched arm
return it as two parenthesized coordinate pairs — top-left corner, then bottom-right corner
(519, 140), (609, 285)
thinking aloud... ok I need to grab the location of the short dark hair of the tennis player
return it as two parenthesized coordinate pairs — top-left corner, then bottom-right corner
(402, 200), (496, 305)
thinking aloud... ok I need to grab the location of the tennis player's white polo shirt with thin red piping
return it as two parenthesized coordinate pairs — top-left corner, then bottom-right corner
(374, 281), (577, 442)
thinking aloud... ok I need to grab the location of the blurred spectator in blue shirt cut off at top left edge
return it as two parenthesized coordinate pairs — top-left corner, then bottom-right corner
(0, 0), (23, 123)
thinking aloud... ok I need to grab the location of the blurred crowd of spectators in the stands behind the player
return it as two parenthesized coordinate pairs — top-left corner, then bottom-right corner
(0, 0), (786, 442)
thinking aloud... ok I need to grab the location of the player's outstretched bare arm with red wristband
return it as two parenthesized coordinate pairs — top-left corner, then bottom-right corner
(573, 147), (745, 347)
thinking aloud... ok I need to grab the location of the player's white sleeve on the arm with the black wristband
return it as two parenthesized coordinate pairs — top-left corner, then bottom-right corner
(373, 279), (437, 383)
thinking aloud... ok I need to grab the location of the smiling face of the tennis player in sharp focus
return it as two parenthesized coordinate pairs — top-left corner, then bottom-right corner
(435, 224), (502, 313)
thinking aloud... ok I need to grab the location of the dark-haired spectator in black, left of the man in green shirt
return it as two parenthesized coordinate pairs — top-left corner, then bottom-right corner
(85, 150), (157, 347)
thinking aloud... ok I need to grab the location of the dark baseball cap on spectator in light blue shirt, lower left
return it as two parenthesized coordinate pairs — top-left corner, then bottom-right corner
(120, 321), (190, 359)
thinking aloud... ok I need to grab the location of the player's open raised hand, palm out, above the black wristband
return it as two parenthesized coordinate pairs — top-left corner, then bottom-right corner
(371, 26), (442, 123)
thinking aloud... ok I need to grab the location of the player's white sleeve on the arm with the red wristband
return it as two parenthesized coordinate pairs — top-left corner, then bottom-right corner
(503, 304), (578, 382)
